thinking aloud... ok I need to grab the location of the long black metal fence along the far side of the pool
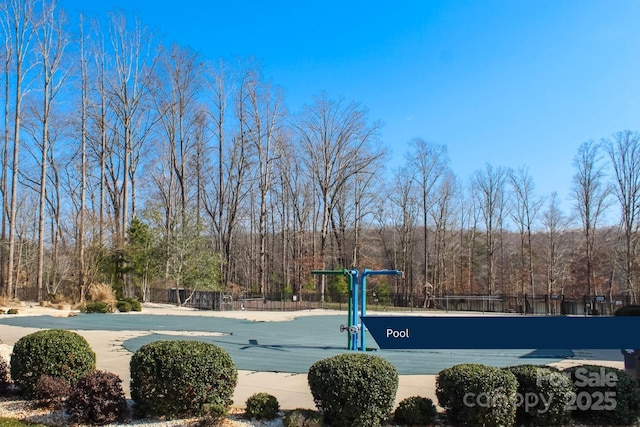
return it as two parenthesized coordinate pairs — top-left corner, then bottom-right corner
(158, 289), (631, 315)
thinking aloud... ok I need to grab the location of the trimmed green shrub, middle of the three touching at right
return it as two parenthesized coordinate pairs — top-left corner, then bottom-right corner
(504, 365), (574, 426)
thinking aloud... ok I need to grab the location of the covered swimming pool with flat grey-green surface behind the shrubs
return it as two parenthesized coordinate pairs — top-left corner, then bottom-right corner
(0, 313), (622, 375)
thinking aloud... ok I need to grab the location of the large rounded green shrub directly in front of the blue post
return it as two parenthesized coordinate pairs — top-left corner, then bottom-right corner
(307, 353), (398, 427)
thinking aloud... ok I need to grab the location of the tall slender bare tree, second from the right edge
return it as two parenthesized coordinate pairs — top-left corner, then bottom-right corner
(572, 141), (610, 310)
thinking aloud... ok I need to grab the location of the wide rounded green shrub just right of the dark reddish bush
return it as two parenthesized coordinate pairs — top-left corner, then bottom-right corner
(130, 340), (238, 417)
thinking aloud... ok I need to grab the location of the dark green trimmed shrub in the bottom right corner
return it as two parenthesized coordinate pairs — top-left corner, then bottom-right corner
(563, 365), (640, 425)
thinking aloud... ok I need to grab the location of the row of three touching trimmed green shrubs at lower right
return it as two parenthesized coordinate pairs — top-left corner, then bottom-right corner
(436, 364), (640, 426)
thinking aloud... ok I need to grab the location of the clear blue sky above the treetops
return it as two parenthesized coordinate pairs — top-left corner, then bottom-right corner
(60, 0), (640, 209)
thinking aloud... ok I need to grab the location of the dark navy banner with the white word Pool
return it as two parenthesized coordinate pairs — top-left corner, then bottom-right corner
(362, 316), (640, 349)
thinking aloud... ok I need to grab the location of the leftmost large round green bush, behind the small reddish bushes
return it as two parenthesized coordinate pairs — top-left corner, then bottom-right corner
(11, 329), (96, 398)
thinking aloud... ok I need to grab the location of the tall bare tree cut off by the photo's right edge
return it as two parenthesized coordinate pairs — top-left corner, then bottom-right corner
(602, 130), (640, 302)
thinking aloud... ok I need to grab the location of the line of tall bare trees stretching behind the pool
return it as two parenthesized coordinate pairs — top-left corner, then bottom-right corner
(0, 0), (640, 304)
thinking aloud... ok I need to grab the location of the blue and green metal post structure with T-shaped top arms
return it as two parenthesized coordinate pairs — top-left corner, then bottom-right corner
(311, 268), (404, 351)
